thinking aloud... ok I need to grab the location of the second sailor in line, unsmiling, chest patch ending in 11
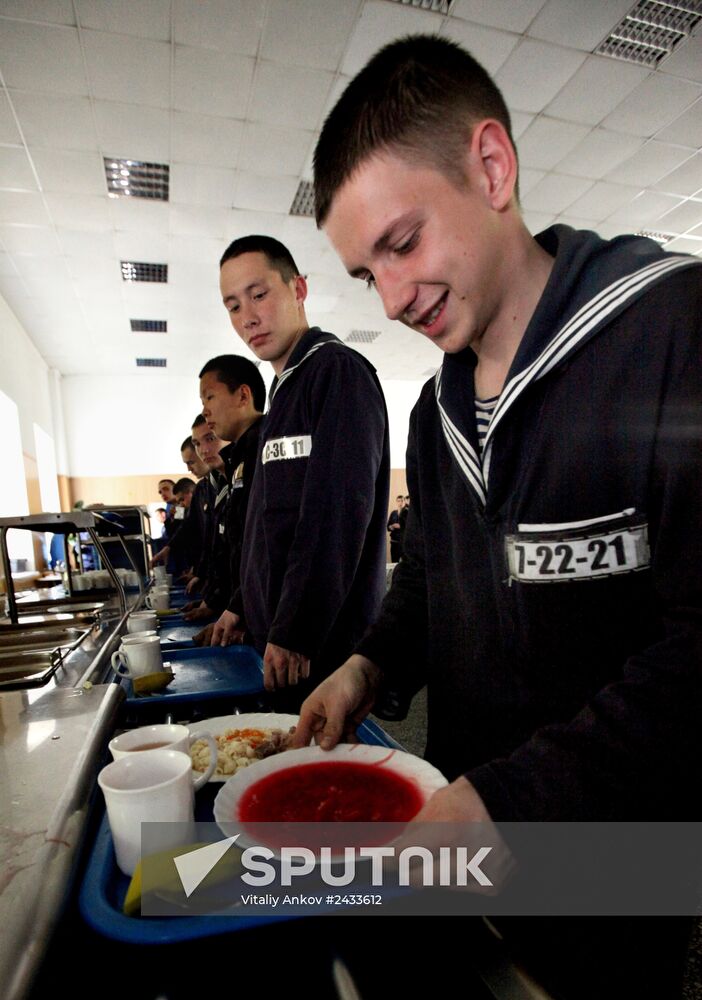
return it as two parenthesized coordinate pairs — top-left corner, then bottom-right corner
(220, 236), (390, 708)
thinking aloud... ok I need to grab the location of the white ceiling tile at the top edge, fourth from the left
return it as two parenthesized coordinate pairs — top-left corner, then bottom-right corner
(260, 0), (364, 70)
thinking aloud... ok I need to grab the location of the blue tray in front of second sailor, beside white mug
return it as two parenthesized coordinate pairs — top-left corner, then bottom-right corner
(120, 646), (263, 708)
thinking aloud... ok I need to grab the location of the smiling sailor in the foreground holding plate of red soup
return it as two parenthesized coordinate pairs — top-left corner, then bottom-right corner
(295, 36), (702, 1000)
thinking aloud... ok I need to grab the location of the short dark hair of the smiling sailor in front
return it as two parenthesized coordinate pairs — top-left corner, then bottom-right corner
(314, 35), (514, 226)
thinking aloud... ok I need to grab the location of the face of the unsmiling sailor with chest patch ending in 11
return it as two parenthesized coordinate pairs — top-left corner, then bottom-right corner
(220, 252), (308, 375)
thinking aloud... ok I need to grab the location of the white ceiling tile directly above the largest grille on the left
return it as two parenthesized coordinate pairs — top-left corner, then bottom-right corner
(95, 101), (170, 163)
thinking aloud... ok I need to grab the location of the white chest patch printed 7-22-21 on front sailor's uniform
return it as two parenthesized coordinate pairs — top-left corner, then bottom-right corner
(505, 521), (651, 583)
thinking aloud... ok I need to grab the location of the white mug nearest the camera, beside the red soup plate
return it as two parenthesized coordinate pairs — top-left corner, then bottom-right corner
(98, 750), (195, 875)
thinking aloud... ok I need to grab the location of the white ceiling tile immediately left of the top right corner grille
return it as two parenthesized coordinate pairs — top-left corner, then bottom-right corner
(527, 0), (632, 52)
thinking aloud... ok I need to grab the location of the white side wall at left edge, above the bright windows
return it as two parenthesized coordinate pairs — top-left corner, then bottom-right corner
(0, 295), (54, 458)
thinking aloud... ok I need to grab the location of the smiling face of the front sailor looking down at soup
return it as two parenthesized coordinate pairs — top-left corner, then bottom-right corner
(324, 130), (511, 354)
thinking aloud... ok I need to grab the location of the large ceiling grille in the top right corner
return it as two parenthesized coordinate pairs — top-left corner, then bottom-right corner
(595, 0), (702, 67)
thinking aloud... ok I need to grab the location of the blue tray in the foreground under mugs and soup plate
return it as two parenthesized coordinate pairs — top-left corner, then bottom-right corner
(79, 719), (403, 944)
